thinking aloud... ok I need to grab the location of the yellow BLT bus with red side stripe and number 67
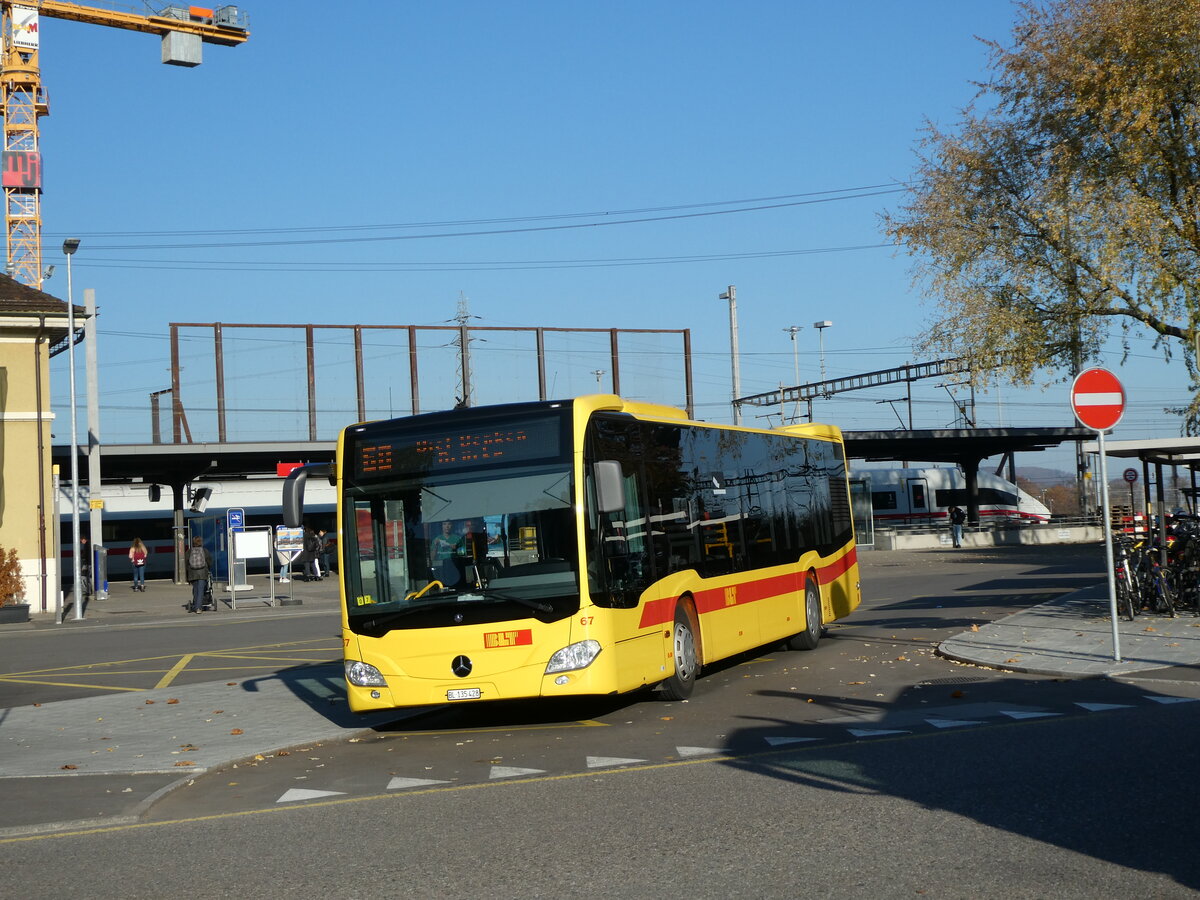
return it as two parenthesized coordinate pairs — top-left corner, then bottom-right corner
(283, 395), (862, 712)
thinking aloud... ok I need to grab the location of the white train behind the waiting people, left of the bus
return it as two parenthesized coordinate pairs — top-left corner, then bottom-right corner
(59, 478), (336, 581)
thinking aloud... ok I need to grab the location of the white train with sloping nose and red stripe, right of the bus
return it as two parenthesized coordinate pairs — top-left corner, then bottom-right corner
(854, 467), (1050, 524)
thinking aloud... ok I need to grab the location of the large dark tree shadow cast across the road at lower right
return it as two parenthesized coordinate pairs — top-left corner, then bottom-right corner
(725, 680), (1200, 896)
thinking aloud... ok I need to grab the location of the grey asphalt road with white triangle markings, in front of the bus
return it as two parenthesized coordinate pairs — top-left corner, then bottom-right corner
(0, 547), (1200, 898)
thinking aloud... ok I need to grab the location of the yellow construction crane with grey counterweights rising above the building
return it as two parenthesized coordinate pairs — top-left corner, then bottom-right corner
(0, 0), (250, 289)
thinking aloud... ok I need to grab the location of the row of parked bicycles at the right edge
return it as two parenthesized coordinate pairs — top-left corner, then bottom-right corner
(1111, 516), (1200, 622)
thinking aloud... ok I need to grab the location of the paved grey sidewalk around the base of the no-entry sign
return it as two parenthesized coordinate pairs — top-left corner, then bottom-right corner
(938, 583), (1200, 678)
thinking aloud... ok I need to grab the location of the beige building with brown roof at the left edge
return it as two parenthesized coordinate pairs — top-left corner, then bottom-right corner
(0, 275), (76, 613)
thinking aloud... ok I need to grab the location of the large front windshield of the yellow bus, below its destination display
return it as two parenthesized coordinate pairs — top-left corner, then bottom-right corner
(342, 463), (578, 628)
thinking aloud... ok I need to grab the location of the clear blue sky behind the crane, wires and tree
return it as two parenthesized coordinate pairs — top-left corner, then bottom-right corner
(41, 0), (1187, 468)
